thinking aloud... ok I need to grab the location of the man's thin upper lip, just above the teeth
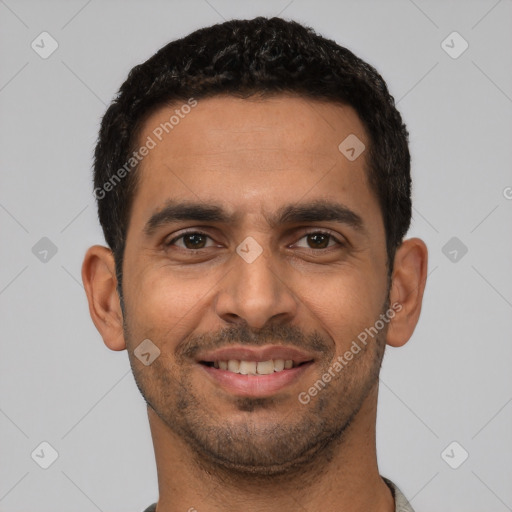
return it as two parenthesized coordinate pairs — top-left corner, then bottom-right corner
(196, 345), (314, 364)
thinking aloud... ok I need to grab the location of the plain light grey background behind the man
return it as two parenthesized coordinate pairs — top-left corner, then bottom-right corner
(0, 0), (512, 512)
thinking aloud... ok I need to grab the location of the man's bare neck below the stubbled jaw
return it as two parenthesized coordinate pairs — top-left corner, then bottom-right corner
(148, 386), (395, 512)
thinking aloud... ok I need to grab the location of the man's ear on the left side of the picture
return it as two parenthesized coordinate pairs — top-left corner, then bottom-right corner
(82, 245), (126, 350)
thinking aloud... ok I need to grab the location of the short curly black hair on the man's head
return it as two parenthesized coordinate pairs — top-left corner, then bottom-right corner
(94, 17), (411, 292)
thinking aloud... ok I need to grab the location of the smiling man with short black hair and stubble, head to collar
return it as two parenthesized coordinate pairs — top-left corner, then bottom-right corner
(82, 18), (427, 512)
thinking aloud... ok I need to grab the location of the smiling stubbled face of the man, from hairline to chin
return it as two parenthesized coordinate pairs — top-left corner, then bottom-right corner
(123, 96), (388, 474)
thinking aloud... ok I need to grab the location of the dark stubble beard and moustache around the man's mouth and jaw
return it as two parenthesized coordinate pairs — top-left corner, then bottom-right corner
(124, 300), (389, 478)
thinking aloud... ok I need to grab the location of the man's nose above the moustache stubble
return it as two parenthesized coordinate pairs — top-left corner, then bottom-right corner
(215, 243), (298, 329)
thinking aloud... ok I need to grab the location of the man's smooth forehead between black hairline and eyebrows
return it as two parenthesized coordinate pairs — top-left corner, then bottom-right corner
(133, 96), (375, 231)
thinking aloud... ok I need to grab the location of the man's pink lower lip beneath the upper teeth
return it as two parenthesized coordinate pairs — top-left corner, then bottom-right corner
(200, 362), (313, 397)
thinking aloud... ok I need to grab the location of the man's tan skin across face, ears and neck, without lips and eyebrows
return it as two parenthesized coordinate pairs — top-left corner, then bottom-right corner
(82, 96), (427, 512)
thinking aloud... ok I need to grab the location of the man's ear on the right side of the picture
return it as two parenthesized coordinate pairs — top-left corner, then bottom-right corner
(386, 238), (428, 347)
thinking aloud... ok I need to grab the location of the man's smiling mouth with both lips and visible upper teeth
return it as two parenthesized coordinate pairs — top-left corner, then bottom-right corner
(197, 346), (314, 397)
